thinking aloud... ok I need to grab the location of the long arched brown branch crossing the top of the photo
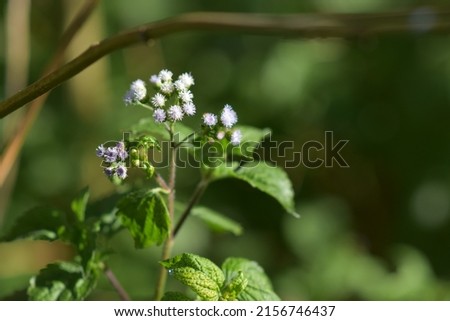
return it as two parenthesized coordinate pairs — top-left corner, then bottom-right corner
(0, 9), (450, 118)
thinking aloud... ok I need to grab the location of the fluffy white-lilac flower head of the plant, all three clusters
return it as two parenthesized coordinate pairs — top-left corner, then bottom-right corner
(107, 69), (243, 182)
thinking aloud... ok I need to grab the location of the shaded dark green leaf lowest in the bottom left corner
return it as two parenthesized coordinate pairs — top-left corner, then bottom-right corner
(27, 262), (97, 301)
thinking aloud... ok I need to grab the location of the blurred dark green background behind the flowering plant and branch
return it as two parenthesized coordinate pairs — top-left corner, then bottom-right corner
(0, 0), (450, 300)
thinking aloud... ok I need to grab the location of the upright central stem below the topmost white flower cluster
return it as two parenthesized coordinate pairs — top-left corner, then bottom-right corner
(154, 124), (177, 301)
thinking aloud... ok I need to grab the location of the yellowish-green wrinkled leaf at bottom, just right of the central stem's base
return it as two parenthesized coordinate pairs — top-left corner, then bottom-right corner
(161, 253), (225, 301)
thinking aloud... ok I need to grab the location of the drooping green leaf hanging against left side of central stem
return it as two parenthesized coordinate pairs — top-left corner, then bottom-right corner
(117, 189), (170, 248)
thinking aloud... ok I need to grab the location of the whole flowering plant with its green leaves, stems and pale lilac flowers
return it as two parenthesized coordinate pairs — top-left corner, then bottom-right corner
(2, 70), (297, 301)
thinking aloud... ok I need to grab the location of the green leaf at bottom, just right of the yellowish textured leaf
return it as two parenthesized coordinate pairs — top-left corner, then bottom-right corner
(222, 258), (280, 301)
